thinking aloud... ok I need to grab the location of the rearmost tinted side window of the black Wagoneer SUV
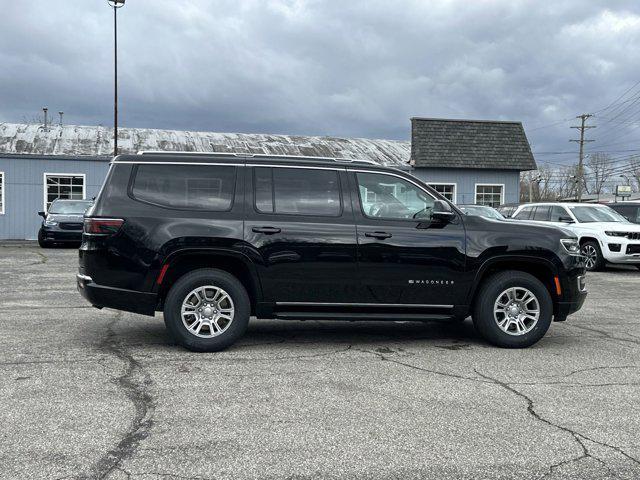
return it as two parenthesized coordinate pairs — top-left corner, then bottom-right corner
(131, 164), (236, 212)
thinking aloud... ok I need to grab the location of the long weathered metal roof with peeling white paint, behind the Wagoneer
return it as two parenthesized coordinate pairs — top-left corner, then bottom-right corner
(0, 123), (411, 166)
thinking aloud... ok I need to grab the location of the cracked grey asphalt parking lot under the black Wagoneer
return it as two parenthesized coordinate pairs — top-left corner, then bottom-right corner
(0, 245), (640, 479)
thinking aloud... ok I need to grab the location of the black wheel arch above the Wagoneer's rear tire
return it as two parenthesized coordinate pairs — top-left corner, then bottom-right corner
(156, 248), (262, 315)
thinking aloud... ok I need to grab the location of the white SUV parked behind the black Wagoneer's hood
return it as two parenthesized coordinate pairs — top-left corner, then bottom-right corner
(512, 203), (640, 270)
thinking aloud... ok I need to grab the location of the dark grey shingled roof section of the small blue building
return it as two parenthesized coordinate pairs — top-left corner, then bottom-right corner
(411, 117), (537, 171)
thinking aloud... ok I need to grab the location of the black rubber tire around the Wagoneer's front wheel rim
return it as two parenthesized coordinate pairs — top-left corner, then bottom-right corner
(473, 272), (553, 348)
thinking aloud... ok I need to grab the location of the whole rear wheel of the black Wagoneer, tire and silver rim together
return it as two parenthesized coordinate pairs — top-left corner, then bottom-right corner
(164, 268), (251, 352)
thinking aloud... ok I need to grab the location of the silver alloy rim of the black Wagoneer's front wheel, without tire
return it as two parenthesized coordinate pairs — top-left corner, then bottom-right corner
(493, 287), (540, 335)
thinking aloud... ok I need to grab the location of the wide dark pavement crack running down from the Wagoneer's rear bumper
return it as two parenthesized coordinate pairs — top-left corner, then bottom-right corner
(81, 312), (155, 479)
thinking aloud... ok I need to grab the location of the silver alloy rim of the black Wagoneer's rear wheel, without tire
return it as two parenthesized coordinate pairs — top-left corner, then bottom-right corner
(180, 285), (235, 338)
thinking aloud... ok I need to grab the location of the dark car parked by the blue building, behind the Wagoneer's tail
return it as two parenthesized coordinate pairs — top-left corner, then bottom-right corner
(38, 199), (93, 248)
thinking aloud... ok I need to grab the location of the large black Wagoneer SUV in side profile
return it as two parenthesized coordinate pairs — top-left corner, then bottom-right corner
(77, 152), (586, 351)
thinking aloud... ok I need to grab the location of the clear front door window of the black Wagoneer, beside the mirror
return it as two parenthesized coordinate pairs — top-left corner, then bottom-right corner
(356, 173), (434, 220)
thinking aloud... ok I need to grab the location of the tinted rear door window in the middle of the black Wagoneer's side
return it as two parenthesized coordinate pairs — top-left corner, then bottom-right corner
(254, 167), (342, 217)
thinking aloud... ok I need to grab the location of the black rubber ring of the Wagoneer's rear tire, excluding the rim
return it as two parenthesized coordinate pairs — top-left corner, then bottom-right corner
(164, 269), (250, 352)
